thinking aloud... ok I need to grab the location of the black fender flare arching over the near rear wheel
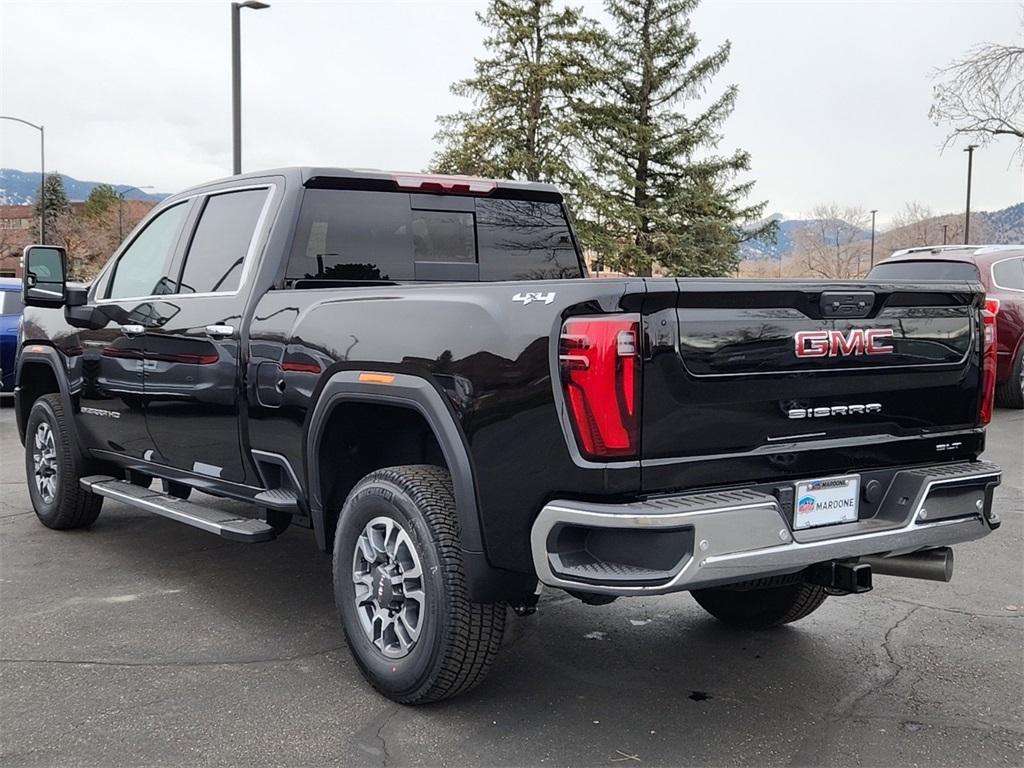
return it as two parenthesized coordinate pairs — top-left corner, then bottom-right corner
(304, 370), (483, 555)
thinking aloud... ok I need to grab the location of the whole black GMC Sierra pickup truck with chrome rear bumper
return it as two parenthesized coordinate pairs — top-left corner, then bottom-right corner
(16, 168), (999, 703)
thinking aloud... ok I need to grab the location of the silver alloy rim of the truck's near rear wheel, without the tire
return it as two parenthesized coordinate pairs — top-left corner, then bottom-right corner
(352, 517), (426, 658)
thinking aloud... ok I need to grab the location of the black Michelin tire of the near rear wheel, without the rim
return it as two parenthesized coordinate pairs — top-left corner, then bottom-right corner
(334, 465), (506, 705)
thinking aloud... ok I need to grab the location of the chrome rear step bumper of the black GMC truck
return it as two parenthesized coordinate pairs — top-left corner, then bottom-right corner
(530, 462), (1000, 595)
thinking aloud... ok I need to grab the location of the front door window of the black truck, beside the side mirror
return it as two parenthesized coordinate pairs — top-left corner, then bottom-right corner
(106, 203), (188, 299)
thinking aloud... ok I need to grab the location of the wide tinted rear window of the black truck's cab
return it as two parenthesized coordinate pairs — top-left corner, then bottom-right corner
(286, 189), (583, 286)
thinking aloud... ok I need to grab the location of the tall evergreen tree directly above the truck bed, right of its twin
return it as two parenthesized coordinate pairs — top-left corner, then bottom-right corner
(580, 0), (766, 276)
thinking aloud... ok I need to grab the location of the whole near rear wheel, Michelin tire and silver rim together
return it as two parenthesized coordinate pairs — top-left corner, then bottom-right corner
(334, 465), (505, 703)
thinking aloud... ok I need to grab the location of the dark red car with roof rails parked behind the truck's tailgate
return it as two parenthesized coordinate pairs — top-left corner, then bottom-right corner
(867, 246), (1024, 409)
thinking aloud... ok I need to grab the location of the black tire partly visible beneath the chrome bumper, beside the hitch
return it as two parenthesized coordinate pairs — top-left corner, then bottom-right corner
(690, 582), (828, 630)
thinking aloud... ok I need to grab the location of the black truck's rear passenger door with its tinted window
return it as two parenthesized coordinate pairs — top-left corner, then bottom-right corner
(145, 185), (272, 482)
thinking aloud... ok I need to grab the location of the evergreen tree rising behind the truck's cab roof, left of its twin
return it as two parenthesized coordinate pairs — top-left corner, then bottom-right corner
(431, 0), (598, 187)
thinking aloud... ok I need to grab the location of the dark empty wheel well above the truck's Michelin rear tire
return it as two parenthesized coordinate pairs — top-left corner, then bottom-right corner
(316, 402), (451, 547)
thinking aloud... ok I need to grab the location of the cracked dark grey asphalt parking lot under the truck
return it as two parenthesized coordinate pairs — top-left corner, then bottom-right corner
(0, 408), (1024, 766)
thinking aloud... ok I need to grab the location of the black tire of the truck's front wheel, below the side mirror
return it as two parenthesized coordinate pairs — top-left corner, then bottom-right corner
(25, 394), (103, 530)
